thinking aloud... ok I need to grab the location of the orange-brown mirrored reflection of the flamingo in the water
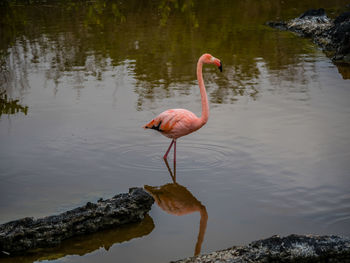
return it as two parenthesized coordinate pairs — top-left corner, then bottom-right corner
(145, 159), (208, 256)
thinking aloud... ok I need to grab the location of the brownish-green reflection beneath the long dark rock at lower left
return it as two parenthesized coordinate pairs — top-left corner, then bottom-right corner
(0, 215), (154, 263)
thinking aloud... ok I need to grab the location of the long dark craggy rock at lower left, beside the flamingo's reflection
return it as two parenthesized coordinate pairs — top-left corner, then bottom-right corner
(0, 188), (154, 256)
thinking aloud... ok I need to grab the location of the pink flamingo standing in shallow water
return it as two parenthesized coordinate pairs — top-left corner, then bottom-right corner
(143, 54), (222, 165)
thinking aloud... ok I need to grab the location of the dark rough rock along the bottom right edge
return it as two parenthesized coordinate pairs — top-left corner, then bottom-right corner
(174, 235), (350, 263)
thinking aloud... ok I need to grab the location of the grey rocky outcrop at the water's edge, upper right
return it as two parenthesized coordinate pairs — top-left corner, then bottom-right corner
(266, 8), (350, 63)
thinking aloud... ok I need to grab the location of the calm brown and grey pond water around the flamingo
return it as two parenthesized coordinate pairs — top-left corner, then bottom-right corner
(0, 0), (350, 262)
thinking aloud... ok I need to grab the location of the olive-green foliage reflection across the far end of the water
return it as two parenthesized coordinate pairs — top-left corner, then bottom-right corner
(0, 0), (347, 110)
